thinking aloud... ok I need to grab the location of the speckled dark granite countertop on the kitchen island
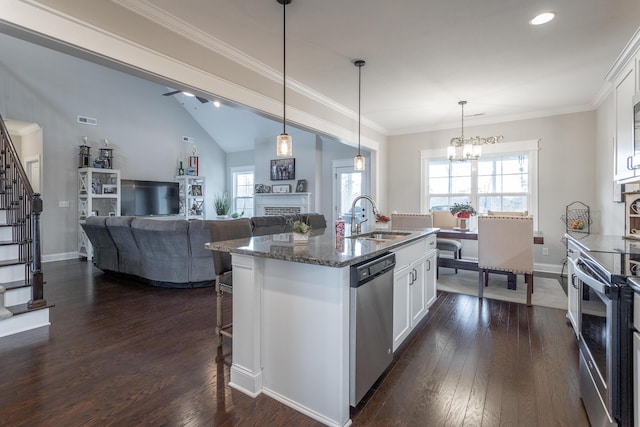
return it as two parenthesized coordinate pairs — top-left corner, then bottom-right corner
(205, 227), (439, 268)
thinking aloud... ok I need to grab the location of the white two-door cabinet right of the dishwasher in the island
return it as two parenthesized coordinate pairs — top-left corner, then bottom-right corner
(393, 235), (436, 351)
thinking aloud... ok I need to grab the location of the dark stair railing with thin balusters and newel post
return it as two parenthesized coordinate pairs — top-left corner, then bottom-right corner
(0, 116), (47, 308)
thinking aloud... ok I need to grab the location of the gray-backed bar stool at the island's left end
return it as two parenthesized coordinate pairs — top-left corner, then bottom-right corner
(211, 218), (251, 347)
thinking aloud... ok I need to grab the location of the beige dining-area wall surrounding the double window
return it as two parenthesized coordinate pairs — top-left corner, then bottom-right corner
(387, 111), (602, 267)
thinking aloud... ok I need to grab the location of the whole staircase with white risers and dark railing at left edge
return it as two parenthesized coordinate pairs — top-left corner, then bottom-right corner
(0, 116), (51, 338)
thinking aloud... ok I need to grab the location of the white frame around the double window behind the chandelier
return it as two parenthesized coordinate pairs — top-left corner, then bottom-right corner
(420, 139), (540, 229)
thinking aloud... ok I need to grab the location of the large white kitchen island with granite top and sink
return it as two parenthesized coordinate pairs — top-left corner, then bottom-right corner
(206, 228), (438, 426)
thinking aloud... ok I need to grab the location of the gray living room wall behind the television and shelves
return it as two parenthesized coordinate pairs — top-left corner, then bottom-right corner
(0, 35), (225, 260)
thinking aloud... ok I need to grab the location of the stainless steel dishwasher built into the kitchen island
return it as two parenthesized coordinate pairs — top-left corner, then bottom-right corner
(349, 253), (396, 406)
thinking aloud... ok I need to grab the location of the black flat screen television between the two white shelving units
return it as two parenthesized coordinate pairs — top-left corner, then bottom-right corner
(120, 179), (180, 216)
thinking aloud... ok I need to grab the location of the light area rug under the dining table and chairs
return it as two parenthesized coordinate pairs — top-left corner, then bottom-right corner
(438, 270), (567, 310)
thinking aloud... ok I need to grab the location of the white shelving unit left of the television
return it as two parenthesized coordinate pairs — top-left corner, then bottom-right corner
(78, 168), (120, 260)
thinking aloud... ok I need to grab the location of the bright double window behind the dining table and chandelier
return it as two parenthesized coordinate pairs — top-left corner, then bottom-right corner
(421, 140), (538, 220)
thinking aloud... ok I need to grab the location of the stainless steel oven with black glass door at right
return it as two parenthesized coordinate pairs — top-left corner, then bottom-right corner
(574, 254), (621, 427)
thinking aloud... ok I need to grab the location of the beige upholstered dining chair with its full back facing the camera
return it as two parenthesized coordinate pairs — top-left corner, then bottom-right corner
(478, 215), (533, 306)
